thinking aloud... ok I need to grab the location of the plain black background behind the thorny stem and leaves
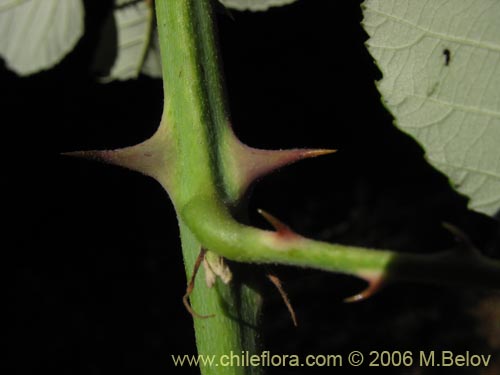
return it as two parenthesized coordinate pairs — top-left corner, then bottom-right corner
(4, 0), (500, 374)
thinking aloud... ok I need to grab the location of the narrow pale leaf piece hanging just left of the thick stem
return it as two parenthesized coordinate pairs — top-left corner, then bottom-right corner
(103, 0), (153, 82)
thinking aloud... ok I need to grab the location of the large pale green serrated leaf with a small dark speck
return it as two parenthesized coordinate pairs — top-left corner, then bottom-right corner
(363, 0), (500, 215)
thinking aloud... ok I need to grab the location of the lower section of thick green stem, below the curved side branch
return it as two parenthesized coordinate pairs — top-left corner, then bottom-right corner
(180, 221), (262, 375)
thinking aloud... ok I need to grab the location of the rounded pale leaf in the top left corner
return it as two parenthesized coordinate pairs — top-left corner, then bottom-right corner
(0, 0), (84, 76)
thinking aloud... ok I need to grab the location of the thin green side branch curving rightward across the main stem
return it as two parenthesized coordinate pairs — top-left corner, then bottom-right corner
(180, 197), (500, 289)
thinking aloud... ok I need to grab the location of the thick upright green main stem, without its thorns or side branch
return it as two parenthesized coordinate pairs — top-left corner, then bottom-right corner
(156, 0), (261, 375)
